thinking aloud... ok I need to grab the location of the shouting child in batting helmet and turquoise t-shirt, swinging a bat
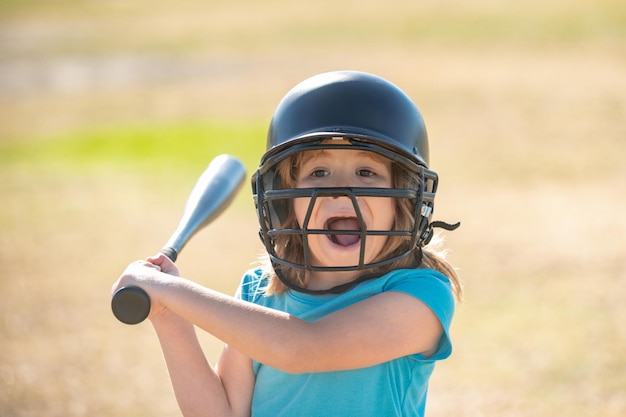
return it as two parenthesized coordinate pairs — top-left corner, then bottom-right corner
(113, 71), (461, 417)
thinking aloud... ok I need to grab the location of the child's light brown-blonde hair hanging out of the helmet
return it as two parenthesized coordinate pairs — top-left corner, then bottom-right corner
(262, 151), (463, 301)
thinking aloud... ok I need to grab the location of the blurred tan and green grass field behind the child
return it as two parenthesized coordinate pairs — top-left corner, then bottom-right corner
(0, 0), (626, 417)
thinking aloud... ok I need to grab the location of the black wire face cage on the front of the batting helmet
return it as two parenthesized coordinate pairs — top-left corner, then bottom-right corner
(253, 138), (438, 271)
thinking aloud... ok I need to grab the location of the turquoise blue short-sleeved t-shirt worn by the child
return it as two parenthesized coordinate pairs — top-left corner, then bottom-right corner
(237, 269), (454, 417)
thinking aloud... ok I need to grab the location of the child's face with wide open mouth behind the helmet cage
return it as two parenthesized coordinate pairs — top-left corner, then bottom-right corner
(294, 145), (395, 266)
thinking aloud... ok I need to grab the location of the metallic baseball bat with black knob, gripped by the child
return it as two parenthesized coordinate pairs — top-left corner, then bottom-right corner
(111, 155), (246, 324)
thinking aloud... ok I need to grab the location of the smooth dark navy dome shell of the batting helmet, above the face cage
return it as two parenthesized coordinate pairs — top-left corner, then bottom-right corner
(261, 71), (428, 168)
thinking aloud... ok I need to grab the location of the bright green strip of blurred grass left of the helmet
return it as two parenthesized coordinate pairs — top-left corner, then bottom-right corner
(0, 121), (266, 175)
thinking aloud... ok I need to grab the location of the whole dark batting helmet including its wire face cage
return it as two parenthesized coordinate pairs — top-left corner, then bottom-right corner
(252, 72), (438, 292)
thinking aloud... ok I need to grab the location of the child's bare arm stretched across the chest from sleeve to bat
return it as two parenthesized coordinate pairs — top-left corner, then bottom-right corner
(114, 255), (443, 373)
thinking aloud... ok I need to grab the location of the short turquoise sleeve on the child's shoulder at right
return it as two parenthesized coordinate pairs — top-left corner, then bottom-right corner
(385, 269), (454, 361)
